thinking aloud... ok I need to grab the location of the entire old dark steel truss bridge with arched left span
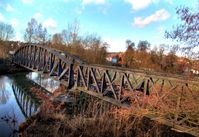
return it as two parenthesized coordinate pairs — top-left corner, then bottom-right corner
(13, 44), (198, 107)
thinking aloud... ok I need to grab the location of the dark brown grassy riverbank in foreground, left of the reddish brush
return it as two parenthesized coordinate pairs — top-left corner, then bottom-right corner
(20, 89), (196, 137)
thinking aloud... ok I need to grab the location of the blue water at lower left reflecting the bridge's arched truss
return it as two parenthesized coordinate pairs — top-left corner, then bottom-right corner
(0, 74), (39, 137)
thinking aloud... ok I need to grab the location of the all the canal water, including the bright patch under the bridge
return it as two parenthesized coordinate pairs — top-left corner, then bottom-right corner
(0, 72), (59, 137)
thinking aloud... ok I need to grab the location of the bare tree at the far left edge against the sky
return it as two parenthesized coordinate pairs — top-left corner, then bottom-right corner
(0, 22), (14, 41)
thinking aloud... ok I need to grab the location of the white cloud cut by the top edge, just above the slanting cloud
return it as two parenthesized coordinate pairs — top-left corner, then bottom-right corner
(124, 0), (154, 10)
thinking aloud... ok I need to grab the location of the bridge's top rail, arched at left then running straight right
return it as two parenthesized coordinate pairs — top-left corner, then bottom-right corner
(14, 43), (199, 84)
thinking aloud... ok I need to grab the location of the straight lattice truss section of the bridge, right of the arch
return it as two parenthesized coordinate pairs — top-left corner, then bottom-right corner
(75, 65), (199, 104)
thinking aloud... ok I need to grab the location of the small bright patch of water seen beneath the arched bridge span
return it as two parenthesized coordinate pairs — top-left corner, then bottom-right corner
(27, 72), (60, 92)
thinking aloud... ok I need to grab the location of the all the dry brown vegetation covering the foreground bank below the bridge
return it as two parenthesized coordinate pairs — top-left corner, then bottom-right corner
(21, 84), (199, 137)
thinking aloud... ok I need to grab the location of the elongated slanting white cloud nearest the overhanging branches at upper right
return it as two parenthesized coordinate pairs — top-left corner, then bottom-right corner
(134, 9), (170, 27)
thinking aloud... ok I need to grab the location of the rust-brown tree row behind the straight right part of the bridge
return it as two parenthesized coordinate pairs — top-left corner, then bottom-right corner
(114, 40), (192, 73)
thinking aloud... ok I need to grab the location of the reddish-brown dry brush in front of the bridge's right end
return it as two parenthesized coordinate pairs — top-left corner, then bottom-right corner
(119, 80), (199, 136)
